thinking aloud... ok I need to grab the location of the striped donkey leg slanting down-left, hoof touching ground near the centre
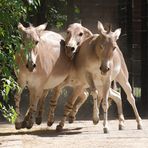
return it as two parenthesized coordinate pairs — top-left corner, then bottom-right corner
(56, 86), (84, 131)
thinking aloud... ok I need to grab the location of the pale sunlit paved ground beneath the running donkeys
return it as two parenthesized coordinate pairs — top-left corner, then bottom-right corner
(0, 120), (148, 148)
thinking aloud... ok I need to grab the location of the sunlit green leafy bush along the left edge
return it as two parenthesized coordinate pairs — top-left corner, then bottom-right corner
(0, 0), (26, 122)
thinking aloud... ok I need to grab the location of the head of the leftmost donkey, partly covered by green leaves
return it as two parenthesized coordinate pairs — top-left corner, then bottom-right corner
(18, 23), (47, 72)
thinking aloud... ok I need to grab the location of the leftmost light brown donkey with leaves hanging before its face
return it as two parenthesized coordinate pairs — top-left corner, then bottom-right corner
(15, 23), (71, 129)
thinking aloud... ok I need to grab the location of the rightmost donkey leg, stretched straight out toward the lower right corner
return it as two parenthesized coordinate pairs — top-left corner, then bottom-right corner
(118, 73), (142, 129)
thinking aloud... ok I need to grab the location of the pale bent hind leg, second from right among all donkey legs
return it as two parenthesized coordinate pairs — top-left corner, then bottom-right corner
(109, 88), (124, 130)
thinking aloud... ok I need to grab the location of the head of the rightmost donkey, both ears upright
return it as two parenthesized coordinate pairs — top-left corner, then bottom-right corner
(97, 21), (121, 74)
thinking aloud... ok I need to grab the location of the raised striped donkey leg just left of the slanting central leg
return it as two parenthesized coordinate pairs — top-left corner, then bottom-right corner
(47, 86), (62, 126)
